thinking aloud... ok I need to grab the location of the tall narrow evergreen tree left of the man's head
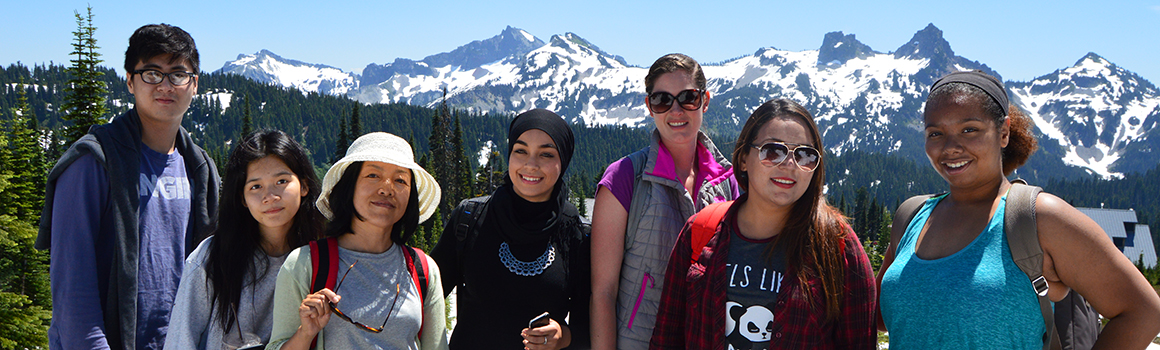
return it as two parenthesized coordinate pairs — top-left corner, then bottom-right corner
(64, 6), (108, 144)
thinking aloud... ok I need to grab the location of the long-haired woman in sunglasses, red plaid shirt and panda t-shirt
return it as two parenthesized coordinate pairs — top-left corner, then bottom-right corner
(650, 99), (878, 349)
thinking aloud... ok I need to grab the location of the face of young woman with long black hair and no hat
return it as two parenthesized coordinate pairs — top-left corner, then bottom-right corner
(242, 155), (309, 236)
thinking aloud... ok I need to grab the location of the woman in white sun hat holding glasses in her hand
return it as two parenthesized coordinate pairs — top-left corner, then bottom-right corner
(268, 132), (447, 350)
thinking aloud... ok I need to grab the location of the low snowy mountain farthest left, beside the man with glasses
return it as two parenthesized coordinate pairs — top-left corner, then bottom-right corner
(218, 50), (358, 95)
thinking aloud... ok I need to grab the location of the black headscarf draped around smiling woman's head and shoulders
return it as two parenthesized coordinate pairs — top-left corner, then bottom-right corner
(488, 109), (578, 243)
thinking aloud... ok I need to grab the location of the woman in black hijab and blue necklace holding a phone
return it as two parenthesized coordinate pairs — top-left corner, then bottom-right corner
(432, 109), (590, 350)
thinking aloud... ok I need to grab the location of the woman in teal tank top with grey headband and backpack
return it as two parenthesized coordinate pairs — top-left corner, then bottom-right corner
(877, 72), (1160, 350)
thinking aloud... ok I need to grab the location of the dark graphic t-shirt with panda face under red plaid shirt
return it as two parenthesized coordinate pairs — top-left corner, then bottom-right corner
(725, 220), (785, 350)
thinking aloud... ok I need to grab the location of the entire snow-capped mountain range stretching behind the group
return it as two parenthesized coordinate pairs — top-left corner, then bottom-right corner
(215, 24), (1160, 178)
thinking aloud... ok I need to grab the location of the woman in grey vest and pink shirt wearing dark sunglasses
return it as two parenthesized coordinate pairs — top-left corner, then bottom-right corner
(592, 53), (738, 349)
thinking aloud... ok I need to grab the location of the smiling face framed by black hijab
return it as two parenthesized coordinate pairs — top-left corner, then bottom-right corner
(508, 129), (561, 203)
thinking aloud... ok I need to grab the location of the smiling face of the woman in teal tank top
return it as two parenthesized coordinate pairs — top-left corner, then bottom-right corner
(922, 95), (1010, 188)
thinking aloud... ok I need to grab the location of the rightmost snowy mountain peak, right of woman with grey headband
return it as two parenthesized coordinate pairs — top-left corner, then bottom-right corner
(1007, 53), (1160, 176)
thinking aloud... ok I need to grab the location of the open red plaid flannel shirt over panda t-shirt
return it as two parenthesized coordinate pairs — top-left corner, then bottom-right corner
(648, 198), (878, 350)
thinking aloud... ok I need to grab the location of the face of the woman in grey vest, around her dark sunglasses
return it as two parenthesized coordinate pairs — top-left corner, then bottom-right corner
(645, 71), (709, 147)
